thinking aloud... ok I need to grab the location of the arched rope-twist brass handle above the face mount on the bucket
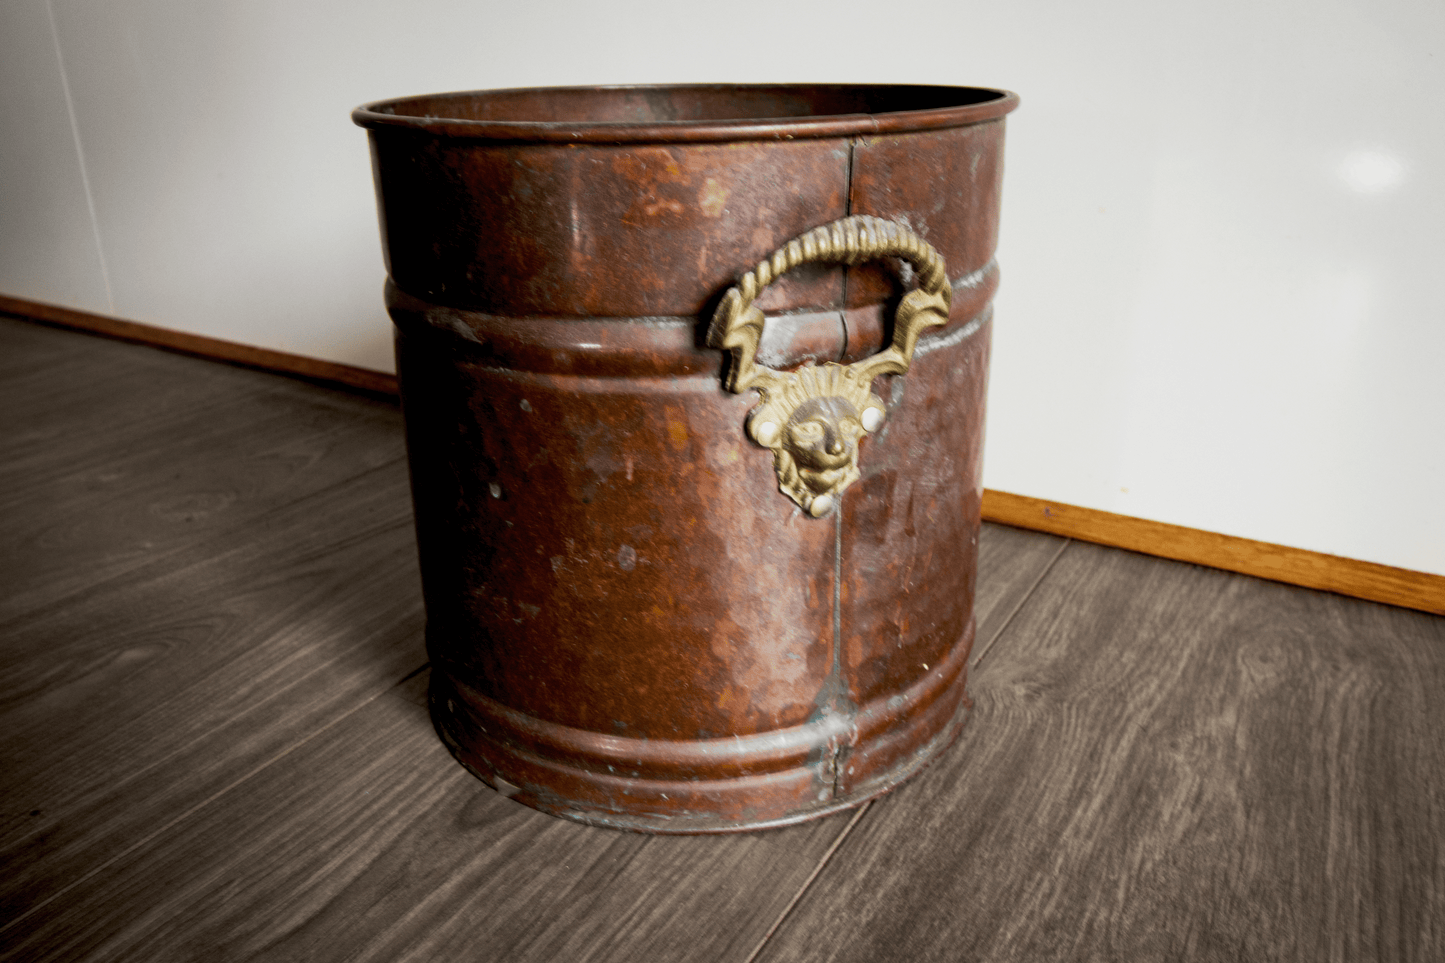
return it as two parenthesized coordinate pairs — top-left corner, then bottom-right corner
(708, 214), (952, 393)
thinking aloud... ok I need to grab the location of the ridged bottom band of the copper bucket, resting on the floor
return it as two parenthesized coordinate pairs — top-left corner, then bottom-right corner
(431, 625), (972, 834)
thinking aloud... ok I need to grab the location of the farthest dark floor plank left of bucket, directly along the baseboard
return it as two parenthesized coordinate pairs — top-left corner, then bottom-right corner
(0, 321), (405, 630)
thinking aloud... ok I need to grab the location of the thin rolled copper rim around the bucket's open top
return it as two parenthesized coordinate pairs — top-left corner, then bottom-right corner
(351, 84), (1019, 143)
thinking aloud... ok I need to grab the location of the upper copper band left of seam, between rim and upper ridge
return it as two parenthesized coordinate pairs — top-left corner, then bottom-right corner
(373, 132), (848, 318)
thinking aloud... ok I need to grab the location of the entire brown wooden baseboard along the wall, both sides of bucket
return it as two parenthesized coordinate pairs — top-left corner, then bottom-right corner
(0, 295), (1445, 615)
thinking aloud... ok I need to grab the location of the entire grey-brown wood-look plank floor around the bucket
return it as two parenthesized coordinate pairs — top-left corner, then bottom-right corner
(8, 313), (1445, 963)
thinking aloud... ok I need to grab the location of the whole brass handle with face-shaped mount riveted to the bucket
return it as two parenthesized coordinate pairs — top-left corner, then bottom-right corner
(708, 215), (952, 518)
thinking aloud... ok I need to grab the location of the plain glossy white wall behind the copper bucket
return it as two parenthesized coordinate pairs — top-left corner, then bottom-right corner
(8, 0), (1445, 574)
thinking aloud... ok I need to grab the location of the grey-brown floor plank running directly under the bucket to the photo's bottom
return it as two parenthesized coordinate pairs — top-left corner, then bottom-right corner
(3, 517), (1061, 960)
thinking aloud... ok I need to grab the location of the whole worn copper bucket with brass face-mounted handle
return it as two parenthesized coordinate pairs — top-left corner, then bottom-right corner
(353, 85), (1017, 833)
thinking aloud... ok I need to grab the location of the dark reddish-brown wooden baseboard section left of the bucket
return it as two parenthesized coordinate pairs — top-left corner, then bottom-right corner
(0, 295), (396, 395)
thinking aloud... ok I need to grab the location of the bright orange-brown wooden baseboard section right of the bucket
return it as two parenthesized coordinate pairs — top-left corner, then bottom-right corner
(983, 490), (1445, 615)
